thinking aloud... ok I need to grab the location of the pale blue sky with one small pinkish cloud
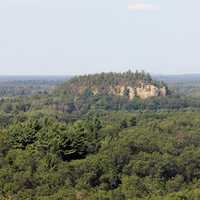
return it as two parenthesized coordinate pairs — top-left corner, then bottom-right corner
(0, 0), (200, 75)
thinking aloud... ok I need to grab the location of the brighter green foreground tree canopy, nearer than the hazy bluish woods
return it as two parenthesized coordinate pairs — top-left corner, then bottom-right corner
(0, 112), (200, 200)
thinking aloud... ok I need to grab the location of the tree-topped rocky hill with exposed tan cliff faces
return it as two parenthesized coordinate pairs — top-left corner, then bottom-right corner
(59, 71), (168, 100)
